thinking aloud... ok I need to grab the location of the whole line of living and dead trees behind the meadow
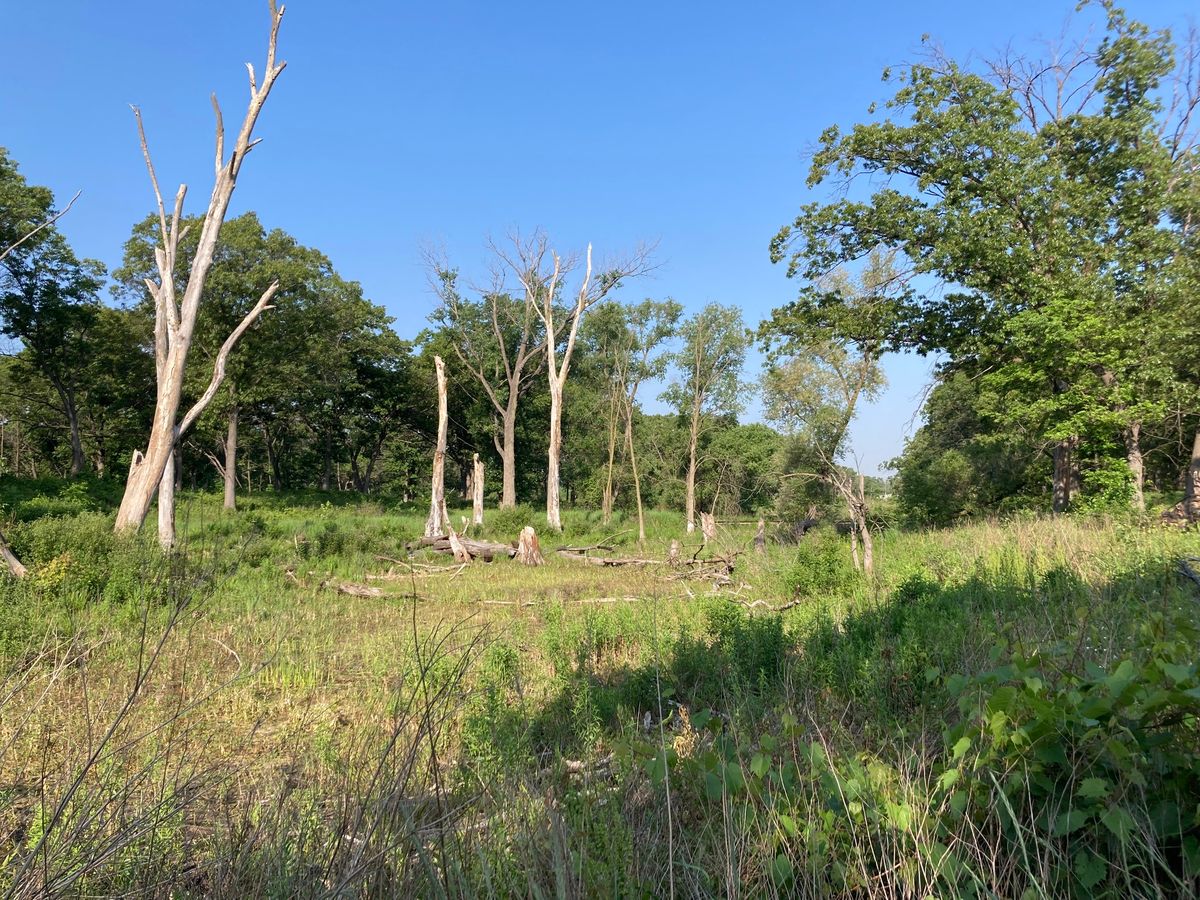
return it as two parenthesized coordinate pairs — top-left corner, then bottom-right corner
(0, 4), (1200, 568)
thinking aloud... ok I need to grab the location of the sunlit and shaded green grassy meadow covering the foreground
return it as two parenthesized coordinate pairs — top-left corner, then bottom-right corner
(0, 490), (1200, 896)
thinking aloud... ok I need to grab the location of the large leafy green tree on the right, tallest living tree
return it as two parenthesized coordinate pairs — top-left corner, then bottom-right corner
(772, 4), (1195, 509)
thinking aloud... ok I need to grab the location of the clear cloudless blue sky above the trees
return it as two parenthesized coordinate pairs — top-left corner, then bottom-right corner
(0, 0), (1195, 470)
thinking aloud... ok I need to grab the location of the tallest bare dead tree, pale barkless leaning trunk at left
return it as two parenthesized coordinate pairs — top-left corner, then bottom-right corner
(115, 0), (286, 547)
